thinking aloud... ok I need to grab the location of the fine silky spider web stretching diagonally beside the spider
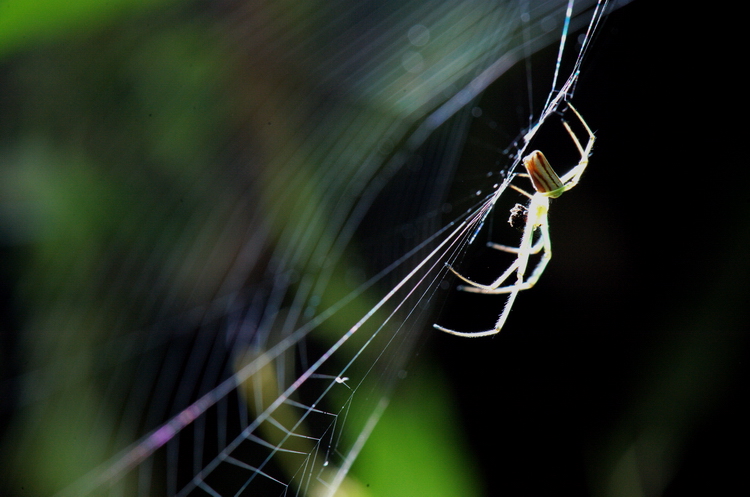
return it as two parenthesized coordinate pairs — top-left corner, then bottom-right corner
(1, 0), (622, 496)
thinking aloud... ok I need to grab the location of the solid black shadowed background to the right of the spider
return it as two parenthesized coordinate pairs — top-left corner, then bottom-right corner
(434, 1), (750, 495)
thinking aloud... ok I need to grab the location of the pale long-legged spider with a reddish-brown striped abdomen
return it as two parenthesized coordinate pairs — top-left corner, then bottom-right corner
(433, 103), (596, 337)
